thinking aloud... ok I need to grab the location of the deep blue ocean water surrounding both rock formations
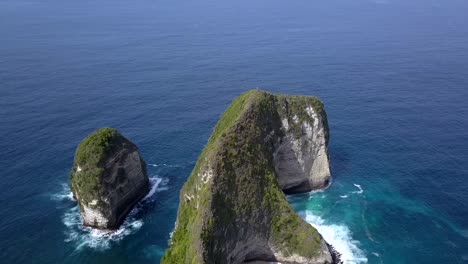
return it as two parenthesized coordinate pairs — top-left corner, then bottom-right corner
(0, 0), (468, 263)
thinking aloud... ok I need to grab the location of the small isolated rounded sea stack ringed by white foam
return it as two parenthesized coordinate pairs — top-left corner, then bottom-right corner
(70, 128), (149, 230)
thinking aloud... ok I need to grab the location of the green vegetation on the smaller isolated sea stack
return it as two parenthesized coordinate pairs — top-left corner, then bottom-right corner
(70, 128), (123, 203)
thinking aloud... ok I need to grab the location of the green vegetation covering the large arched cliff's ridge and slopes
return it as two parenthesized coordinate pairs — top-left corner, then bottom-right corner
(162, 90), (326, 264)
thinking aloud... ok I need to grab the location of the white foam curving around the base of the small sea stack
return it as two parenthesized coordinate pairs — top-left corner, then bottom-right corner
(62, 177), (168, 251)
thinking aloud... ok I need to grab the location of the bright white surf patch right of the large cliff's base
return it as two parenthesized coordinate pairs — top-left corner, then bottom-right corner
(305, 211), (367, 264)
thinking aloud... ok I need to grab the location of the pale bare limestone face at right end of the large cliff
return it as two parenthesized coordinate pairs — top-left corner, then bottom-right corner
(273, 96), (330, 193)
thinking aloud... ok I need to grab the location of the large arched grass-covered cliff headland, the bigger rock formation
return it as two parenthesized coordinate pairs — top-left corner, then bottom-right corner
(162, 90), (333, 264)
